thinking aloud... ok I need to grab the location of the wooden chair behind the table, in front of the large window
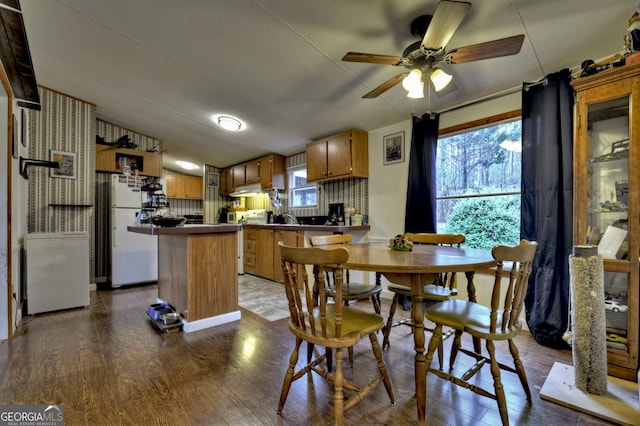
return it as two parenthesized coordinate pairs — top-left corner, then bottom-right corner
(382, 232), (465, 367)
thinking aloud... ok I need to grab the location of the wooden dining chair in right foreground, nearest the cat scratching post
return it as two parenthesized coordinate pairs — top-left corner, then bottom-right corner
(425, 240), (538, 425)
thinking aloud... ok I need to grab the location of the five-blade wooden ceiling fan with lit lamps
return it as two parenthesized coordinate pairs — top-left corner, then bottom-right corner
(342, 0), (524, 99)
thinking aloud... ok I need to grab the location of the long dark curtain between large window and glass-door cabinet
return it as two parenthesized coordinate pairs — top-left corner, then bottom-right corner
(520, 69), (573, 348)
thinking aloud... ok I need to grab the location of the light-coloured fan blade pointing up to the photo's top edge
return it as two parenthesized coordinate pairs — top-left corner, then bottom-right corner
(422, 0), (471, 52)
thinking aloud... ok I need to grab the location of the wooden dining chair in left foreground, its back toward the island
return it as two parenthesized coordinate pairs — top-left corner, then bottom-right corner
(277, 242), (395, 425)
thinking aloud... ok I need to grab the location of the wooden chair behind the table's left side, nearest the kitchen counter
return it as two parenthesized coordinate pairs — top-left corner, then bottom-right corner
(307, 234), (382, 371)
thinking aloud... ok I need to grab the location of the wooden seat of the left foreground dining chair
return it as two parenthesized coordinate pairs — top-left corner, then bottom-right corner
(296, 304), (384, 339)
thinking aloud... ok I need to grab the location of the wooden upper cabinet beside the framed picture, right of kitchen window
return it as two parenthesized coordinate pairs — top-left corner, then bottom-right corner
(307, 129), (369, 182)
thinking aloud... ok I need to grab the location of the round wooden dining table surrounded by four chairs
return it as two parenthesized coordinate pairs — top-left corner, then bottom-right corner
(343, 243), (496, 424)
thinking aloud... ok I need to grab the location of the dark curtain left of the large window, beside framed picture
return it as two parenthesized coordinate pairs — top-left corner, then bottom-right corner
(404, 113), (440, 232)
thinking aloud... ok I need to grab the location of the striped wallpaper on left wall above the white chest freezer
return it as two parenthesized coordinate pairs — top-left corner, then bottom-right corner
(27, 87), (96, 283)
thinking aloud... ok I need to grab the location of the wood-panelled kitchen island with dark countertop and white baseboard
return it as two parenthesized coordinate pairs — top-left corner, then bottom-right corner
(127, 225), (241, 333)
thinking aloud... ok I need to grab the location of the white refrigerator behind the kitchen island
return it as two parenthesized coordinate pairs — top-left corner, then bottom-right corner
(110, 175), (164, 287)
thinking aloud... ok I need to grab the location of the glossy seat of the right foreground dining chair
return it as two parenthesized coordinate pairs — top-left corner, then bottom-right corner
(425, 299), (522, 340)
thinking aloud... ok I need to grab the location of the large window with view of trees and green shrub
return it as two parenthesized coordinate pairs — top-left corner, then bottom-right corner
(436, 117), (522, 249)
